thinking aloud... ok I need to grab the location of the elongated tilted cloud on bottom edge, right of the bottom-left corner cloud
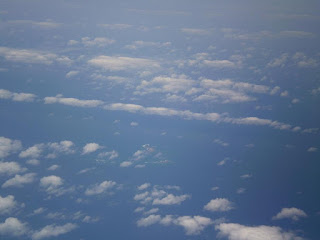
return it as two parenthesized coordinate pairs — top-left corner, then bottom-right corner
(32, 223), (78, 240)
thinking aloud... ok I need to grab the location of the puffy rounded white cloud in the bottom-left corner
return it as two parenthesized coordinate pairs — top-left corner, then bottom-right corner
(0, 217), (29, 237)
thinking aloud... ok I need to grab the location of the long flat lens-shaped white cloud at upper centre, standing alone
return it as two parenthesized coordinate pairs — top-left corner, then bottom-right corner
(88, 55), (160, 71)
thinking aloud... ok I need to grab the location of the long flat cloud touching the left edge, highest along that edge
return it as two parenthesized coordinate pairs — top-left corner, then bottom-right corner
(0, 47), (72, 65)
